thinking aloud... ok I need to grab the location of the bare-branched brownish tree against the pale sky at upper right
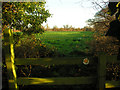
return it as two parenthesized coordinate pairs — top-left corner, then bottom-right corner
(87, 0), (115, 35)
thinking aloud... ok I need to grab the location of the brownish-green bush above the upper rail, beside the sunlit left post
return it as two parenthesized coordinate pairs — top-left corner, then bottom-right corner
(15, 36), (56, 58)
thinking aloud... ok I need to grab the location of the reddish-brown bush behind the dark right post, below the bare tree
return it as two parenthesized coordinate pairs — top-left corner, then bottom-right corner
(90, 36), (119, 55)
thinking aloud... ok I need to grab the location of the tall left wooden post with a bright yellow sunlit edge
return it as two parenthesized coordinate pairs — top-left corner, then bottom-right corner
(3, 27), (18, 89)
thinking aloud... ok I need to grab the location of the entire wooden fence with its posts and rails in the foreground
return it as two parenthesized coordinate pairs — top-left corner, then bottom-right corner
(4, 29), (120, 90)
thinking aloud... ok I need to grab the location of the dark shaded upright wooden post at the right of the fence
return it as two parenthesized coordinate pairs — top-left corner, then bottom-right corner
(98, 53), (107, 90)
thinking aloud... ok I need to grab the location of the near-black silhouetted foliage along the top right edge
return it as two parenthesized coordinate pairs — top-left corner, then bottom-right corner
(106, 2), (120, 59)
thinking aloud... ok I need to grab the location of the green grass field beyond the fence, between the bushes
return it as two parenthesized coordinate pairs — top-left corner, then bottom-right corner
(36, 31), (93, 56)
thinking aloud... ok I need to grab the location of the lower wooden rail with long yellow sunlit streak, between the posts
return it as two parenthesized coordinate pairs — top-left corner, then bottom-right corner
(18, 77), (96, 85)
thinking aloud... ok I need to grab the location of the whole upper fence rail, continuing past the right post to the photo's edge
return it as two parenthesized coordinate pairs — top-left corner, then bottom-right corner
(15, 55), (120, 65)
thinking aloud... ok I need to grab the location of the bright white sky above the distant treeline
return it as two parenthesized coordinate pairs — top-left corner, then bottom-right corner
(43, 0), (109, 28)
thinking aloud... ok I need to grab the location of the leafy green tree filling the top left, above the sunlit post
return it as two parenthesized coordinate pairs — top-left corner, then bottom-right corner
(2, 1), (51, 34)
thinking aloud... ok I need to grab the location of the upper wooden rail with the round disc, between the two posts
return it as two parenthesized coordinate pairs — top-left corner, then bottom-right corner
(15, 57), (94, 65)
